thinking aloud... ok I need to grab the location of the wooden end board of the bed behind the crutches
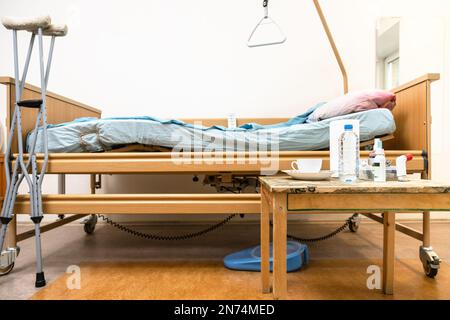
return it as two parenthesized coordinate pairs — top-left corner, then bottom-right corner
(0, 77), (102, 152)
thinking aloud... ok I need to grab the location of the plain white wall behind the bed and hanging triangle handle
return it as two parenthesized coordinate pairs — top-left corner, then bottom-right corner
(0, 0), (450, 222)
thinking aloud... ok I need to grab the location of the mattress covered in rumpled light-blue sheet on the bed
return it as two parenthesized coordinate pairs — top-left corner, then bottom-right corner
(27, 109), (396, 153)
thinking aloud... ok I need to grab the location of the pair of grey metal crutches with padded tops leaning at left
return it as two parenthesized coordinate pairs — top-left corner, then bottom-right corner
(0, 16), (67, 287)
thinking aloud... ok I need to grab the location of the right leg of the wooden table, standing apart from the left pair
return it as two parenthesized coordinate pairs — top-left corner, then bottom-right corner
(383, 212), (395, 295)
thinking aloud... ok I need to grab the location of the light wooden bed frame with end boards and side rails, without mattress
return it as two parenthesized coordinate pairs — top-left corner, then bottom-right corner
(0, 74), (439, 272)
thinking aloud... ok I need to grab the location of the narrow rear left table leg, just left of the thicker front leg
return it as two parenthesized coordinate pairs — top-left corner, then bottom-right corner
(261, 188), (270, 293)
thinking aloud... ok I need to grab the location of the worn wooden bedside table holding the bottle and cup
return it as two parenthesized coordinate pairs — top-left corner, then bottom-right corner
(260, 176), (450, 299)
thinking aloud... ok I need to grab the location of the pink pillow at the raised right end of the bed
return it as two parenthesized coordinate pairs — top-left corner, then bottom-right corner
(307, 90), (396, 122)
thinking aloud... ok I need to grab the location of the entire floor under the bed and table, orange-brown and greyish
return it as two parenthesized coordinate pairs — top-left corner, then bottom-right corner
(0, 220), (450, 300)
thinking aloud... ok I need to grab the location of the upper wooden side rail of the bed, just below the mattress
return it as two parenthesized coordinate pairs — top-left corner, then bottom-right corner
(15, 150), (426, 175)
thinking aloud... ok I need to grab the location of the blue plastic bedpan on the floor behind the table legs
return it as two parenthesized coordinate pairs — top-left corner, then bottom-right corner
(223, 241), (309, 272)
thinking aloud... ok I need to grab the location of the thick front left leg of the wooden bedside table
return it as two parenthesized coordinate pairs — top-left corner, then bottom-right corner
(273, 193), (287, 299)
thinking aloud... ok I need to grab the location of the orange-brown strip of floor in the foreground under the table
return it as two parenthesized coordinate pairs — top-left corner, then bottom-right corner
(32, 260), (450, 300)
